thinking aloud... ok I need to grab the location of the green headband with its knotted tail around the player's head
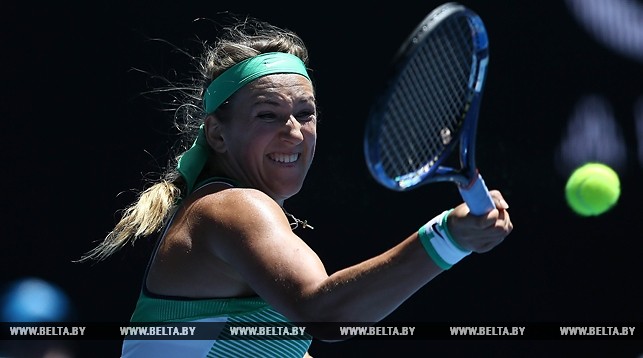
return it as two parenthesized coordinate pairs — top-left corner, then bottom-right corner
(177, 52), (310, 195)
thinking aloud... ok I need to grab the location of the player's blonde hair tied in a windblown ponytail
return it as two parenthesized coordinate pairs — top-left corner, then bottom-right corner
(79, 17), (308, 261)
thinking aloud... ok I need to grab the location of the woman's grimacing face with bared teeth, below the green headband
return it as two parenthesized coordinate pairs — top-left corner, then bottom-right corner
(216, 74), (317, 204)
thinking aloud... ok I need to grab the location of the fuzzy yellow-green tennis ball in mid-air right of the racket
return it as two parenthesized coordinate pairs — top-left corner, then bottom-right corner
(565, 163), (621, 216)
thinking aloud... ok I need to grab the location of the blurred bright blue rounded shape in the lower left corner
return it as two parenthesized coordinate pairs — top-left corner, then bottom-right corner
(1, 277), (70, 322)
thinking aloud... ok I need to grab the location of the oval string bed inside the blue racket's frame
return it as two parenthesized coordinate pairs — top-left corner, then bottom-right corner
(379, 17), (474, 178)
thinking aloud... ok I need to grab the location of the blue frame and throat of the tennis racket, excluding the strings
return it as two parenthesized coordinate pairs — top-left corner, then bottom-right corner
(364, 3), (495, 215)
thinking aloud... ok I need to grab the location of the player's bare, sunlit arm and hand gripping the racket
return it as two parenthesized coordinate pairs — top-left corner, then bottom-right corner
(192, 189), (511, 322)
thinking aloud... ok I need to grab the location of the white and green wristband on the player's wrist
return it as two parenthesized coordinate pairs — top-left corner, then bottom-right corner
(418, 210), (471, 270)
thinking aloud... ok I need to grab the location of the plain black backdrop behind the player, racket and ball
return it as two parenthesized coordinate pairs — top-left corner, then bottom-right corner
(0, 0), (643, 357)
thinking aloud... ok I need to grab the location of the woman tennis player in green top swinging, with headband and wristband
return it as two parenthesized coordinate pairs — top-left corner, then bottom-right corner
(83, 19), (513, 357)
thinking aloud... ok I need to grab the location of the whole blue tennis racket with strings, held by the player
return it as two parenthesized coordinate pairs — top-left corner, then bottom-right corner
(364, 2), (495, 215)
